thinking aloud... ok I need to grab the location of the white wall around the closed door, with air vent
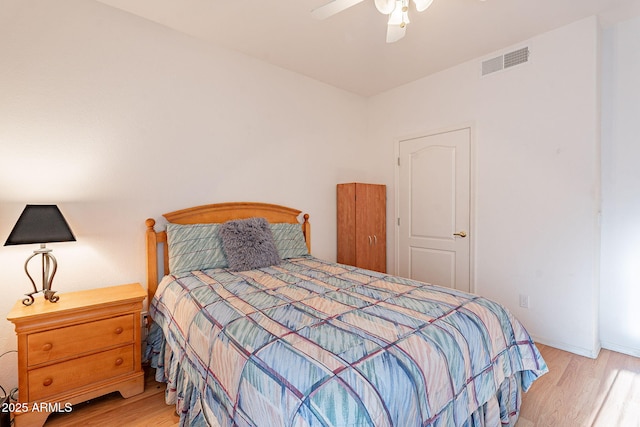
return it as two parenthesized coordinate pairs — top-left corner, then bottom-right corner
(368, 18), (600, 356)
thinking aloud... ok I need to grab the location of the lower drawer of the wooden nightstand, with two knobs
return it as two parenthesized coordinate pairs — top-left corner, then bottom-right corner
(28, 345), (134, 402)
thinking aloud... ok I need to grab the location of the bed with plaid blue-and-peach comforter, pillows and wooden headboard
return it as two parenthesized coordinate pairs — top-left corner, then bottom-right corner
(146, 203), (547, 427)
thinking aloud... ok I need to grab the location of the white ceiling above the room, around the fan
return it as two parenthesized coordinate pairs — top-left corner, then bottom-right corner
(97, 0), (640, 96)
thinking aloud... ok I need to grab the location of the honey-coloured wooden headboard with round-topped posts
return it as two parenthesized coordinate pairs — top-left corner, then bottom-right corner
(145, 202), (311, 302)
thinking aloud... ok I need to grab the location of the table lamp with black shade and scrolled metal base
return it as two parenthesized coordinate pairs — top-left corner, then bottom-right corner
(4, 205), (76, 305)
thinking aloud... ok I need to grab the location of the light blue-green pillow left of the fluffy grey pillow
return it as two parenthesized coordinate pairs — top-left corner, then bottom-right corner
(167, 223), (227, 274)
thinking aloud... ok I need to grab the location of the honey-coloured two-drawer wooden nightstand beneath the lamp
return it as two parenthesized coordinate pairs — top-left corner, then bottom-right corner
(7, 283), (147, 427)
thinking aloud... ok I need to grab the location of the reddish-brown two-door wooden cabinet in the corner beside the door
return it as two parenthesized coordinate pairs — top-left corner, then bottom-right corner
(337, 183), (387, 273)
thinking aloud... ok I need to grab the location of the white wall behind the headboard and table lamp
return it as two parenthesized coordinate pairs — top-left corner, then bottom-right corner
(0, 0), (370, 388)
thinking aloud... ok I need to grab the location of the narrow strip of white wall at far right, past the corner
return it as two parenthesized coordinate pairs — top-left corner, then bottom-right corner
(600, 14), (640, 357)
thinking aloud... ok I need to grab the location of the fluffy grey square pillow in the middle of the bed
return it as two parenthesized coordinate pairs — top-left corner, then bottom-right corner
(219, 218), (281, 271)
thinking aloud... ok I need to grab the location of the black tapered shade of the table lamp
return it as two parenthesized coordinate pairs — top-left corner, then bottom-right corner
(4, 205), (76, 246)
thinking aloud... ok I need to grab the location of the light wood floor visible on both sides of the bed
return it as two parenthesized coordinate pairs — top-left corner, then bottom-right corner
(45, 345), (640, 427)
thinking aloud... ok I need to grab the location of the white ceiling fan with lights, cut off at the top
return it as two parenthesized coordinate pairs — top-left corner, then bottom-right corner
(311, 0), (433, 43)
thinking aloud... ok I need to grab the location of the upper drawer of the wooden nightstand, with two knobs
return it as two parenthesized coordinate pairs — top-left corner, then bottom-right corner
(27, 314), (134, 366)
